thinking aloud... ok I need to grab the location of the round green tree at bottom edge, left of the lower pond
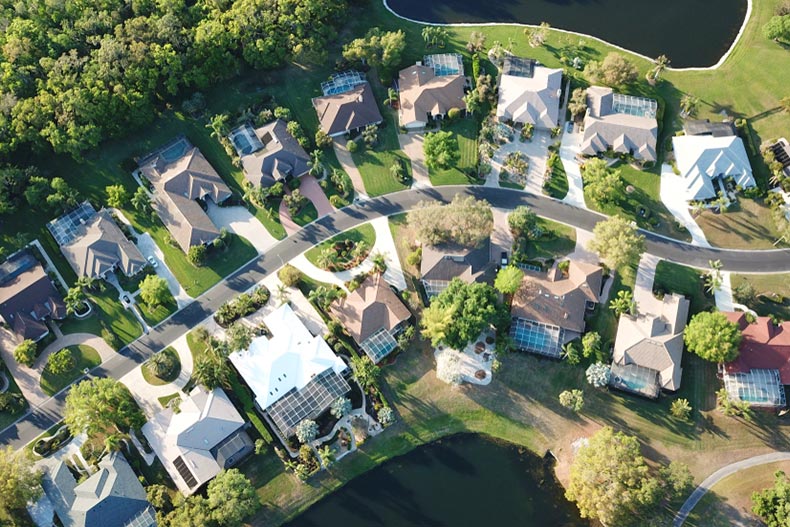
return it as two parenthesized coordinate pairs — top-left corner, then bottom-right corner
(206, 468), (261, 526)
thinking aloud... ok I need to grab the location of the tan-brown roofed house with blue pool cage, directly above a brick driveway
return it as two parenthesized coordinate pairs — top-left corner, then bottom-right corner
(398, 53), (466, 129)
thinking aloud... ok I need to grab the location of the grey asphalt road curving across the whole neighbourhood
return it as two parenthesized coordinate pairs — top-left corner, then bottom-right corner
(0, 186), (790, 448)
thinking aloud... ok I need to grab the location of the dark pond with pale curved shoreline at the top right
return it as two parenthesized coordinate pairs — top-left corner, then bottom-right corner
(386, 0), (747, 68)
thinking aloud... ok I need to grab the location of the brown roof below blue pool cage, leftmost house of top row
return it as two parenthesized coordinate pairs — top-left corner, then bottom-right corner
(313, 81), (384, 137)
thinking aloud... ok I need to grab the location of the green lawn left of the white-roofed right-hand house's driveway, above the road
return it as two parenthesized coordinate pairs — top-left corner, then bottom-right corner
(584, 163), (691, 241)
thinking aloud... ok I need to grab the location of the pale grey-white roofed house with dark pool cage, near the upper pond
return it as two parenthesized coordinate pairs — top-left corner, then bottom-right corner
(496, 56), (562, 130)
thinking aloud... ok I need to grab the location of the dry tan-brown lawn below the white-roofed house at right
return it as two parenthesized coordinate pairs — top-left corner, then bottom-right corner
(697, 197), (786, 249)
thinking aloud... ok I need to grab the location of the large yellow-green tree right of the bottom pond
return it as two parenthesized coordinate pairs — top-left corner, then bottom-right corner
(565, 426), (660, 525)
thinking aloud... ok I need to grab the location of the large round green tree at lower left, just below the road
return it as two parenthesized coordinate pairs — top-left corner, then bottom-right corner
(63, 378), (145, 436)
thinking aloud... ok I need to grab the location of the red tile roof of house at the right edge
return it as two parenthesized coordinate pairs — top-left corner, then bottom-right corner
(724, 311), (790, 384)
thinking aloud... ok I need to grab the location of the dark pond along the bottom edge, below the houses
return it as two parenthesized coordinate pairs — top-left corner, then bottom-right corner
(287, 434), (589, 527)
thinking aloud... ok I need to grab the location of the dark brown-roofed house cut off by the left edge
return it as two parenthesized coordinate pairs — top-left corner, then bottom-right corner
(0, 250), (66, 342)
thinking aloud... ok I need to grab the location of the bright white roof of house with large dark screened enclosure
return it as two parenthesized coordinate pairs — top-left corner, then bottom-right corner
(230, 304), (346, 410)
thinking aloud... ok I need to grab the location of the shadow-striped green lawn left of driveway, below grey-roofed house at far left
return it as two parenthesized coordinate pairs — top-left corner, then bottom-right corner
(60, 287), (143, 345)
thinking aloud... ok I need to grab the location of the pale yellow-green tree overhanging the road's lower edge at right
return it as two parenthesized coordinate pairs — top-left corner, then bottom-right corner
(589, 216), (645, 269)
